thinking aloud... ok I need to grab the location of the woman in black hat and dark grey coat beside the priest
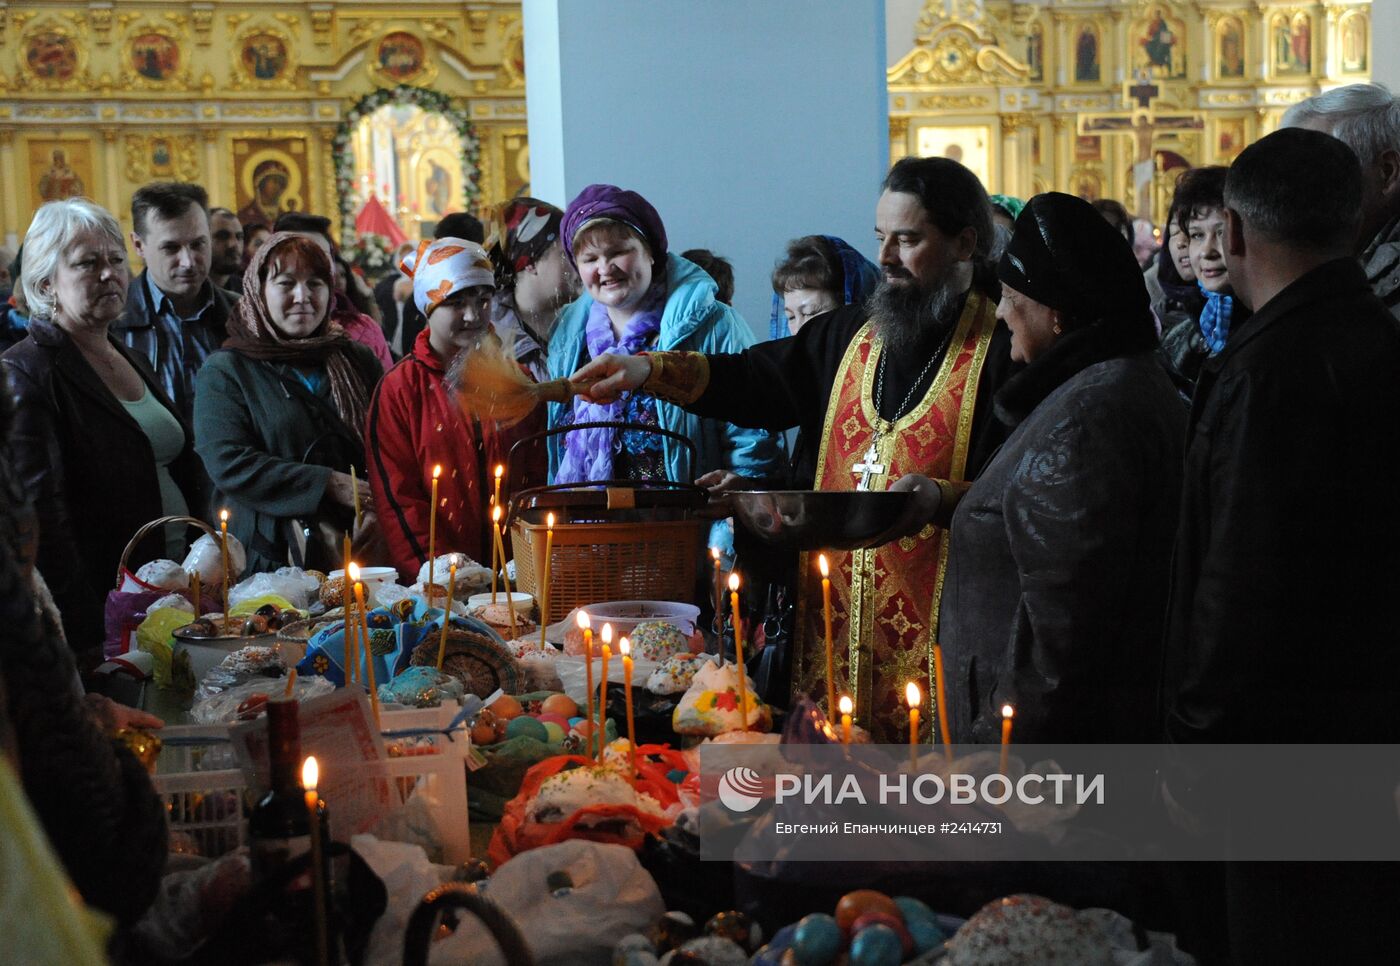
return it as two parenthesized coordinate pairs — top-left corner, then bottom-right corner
(902, 193), (1186, 742)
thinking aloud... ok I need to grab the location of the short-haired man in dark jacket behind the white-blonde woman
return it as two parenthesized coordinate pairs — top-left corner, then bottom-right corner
(112, 182), (238, 421)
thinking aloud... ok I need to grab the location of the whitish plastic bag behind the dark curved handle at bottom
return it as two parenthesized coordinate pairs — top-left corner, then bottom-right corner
(431, 841), (666, 966)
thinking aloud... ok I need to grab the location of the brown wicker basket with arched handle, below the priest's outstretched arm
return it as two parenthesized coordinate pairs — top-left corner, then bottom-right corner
(510, 423), (710, 624)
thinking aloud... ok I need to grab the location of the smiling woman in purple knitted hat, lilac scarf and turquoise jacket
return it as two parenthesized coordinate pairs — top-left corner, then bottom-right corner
(549, 185), (781, 483)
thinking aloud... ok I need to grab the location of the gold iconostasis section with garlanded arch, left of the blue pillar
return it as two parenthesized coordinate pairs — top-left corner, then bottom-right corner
(0, 0), (529, 244)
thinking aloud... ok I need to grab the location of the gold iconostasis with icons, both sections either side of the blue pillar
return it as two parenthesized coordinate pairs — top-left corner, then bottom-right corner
(0, 0), (1372, 242)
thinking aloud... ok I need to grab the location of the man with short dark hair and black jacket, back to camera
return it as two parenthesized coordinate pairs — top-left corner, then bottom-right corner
(1165, 129), (1400, 963)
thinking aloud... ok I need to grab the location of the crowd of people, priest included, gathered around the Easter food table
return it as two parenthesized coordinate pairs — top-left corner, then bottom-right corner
(0, 84), (1400, 962)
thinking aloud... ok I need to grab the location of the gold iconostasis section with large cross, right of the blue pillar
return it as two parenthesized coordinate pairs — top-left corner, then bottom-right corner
(889, 0), (1371, 223)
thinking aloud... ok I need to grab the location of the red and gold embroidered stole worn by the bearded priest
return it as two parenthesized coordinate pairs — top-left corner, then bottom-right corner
(792, 291), (997, 742)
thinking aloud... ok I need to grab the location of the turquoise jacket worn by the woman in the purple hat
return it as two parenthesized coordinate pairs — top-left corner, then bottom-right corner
(549, 255), (784, 482)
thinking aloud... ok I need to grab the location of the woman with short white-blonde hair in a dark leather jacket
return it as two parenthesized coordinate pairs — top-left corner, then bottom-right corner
(3, 199), (199, 665)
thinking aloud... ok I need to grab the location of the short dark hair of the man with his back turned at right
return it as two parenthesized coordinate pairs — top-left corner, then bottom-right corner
(1225, 127), (1361, 252)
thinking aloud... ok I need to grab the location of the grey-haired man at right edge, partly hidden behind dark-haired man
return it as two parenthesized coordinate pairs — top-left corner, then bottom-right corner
(1282, 84), (1400, 319)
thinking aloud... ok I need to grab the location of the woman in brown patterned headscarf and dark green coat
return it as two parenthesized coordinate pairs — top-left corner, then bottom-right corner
(195, 231), (382, 571)
